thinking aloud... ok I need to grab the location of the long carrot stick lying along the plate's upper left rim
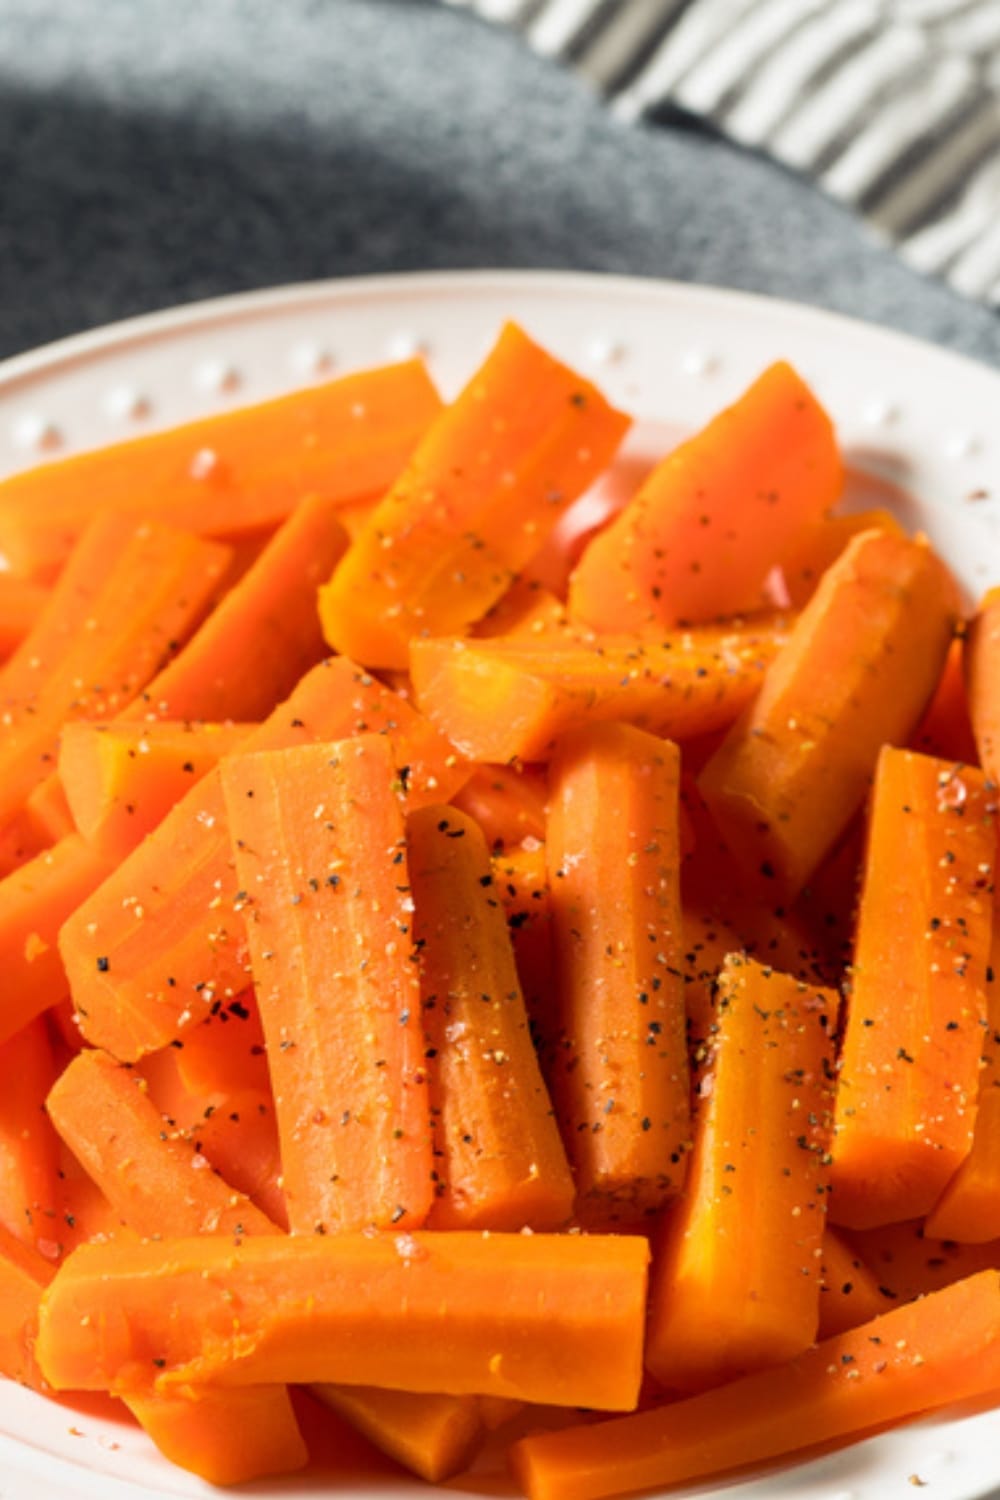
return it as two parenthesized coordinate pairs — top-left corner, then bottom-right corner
(0, 360), (441, 578)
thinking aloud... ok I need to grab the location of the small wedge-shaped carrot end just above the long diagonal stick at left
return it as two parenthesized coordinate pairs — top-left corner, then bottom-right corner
(58, 719), (253, 864)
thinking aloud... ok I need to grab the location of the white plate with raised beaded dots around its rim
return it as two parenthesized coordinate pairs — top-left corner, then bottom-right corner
(0, 272), (1000, 1500)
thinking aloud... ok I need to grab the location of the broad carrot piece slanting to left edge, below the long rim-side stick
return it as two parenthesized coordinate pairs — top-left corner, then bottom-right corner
(0, 515), (229, 824)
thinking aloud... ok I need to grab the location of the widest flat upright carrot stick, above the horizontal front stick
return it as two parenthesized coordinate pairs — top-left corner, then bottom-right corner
(222, 735), (432, 1235)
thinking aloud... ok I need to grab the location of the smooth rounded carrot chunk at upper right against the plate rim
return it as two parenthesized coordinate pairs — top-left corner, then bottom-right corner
(570, 363), (844, 630)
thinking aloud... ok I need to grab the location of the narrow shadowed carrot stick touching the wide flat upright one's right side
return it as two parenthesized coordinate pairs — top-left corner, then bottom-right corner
(406, 807), (574, 1230)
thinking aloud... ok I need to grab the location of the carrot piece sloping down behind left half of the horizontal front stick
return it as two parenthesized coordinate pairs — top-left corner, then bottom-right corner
(48, 1049), (276, 1236)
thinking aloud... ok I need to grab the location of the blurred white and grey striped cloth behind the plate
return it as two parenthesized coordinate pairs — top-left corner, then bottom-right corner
(448, 0), (1000, 306)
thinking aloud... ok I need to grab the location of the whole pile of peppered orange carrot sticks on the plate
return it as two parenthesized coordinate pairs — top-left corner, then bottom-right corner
(0, 326), (1000, 1500)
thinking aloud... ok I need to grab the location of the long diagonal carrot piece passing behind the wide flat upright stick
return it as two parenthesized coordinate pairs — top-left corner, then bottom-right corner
(60, 657), (469, 1062)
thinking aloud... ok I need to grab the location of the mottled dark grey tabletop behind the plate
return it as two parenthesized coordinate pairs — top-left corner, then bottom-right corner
(0, 0), (1000, 365)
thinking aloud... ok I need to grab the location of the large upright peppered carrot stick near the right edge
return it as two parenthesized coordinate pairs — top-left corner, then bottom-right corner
(831, 746), (997, 1229)
